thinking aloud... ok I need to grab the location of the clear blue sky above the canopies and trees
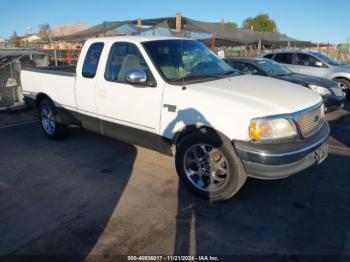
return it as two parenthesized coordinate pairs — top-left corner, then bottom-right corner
(0, 0), (350, 44)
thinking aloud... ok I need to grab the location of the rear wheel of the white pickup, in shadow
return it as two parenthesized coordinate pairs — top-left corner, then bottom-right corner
(38, 98), (68, 140)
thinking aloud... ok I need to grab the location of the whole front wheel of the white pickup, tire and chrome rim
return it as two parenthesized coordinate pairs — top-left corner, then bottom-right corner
(175, 129), (247, 201)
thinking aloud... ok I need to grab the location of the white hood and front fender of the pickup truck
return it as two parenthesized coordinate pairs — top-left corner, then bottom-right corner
(161, 75), (322, 141)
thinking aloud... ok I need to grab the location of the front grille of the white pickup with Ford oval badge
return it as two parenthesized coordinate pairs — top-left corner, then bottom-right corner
(298, 106), (323, 137)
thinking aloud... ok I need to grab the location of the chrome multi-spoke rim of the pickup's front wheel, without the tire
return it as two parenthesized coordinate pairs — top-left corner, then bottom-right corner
(184, 144), (229, 192)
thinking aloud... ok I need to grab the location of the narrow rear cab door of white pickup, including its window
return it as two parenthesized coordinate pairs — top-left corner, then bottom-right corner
(75, 42), (104, 132)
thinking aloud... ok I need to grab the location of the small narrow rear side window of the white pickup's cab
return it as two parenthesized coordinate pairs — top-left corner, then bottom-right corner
(82, 43), (104, 78)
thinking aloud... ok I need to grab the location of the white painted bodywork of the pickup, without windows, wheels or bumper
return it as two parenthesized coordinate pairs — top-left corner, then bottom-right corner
(21, 37), (322, 141)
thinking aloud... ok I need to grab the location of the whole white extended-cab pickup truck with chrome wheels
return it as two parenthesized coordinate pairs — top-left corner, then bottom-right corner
(21, 37), (329, 200)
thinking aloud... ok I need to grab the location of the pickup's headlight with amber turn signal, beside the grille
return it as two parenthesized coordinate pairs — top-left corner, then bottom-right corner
(249, 118), (297, 141)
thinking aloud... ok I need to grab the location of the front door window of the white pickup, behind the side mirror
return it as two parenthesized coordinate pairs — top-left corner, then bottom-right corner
(105, 43), (154, 83)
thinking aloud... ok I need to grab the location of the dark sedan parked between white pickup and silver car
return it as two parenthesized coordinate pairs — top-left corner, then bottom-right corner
(225, 57), (345, 112)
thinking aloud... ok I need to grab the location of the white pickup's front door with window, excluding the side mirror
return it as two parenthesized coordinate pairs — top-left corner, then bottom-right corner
(96, 42), (163, 147)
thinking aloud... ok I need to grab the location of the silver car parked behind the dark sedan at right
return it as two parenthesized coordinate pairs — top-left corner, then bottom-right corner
(263, 50), (350, 98)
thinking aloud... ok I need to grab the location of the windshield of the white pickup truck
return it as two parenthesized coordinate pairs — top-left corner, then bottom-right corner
(143, 39), (238, 82)
